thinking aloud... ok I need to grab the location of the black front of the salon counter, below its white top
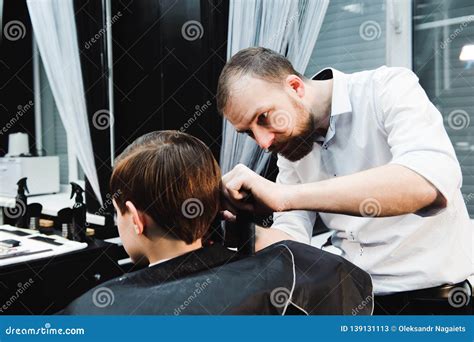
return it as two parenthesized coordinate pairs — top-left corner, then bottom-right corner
(0, 239), (123, 315)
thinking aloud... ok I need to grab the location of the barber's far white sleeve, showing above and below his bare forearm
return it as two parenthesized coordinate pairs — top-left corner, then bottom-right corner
(272, 156), (316, 243)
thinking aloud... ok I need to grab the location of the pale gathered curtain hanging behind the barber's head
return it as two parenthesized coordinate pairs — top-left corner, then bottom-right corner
(220, 0), (329, 173)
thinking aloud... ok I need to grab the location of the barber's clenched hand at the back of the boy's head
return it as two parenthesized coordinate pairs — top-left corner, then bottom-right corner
(222, 164), (291, 214)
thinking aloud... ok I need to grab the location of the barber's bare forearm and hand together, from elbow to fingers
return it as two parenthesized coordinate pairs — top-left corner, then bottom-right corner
(222, 164), (440, 217)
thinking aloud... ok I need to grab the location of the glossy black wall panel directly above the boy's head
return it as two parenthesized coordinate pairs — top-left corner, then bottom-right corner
(112, 0), (228, 157)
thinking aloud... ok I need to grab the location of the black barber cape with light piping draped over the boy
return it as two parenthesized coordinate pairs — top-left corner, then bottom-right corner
(59, 241), (373, 315)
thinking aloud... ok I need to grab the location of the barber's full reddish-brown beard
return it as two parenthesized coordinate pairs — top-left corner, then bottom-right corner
(272, 113), (317, 162)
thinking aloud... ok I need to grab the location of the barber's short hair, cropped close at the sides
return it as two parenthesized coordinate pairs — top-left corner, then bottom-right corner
(216, 47), (304, 114)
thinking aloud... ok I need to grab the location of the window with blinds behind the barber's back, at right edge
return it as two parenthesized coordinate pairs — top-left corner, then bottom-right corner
(413, 0), (474, 218)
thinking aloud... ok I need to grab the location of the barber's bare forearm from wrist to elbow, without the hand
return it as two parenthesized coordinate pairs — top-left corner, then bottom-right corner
(288, 164), (446, 216)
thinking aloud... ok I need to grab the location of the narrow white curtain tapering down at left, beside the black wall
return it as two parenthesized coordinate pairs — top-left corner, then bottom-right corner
(27, 0), (102, 204)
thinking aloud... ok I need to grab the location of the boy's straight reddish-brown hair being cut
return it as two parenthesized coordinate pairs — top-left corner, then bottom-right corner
(110, 131), (221, 244)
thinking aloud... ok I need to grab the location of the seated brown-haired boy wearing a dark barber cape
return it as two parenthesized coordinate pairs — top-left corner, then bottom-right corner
(62, 131), (372, 315)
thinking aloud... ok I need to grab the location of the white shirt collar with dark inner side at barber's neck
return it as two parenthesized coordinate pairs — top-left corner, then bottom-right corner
(311, 68), (352, 116)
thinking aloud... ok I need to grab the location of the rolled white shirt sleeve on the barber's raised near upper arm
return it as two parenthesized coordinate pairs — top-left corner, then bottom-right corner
(374, 68), (462, 216)
